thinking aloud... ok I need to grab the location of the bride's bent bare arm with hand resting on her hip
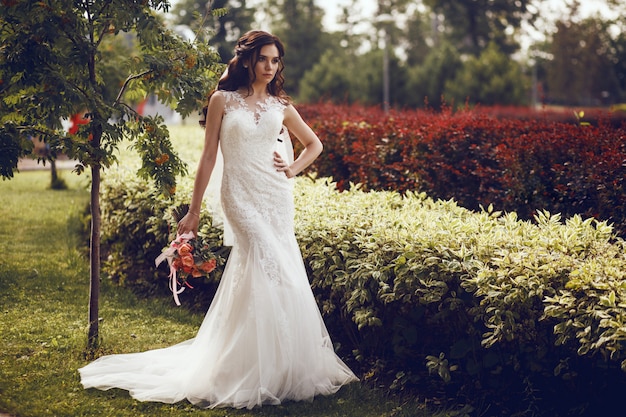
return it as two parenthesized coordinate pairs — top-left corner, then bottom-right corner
(274, 105), (324, 178)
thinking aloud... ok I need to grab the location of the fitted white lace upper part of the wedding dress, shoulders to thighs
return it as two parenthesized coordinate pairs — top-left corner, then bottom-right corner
(220, 91), (293, 254)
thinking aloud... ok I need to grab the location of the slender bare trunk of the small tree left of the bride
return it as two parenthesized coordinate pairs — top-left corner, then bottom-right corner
(87, 164), (101, 349)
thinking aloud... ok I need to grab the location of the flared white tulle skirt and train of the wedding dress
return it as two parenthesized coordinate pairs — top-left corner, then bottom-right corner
(79, 232), (357, 408)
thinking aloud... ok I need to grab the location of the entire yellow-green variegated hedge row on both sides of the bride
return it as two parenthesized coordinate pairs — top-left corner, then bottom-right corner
(102, 173), (626, 415)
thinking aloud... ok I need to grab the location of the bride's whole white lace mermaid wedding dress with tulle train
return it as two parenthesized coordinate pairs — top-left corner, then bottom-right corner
(79, 91), (357, 408)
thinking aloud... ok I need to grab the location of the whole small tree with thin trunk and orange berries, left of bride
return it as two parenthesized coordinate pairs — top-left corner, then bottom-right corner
(0, 0), (223, 349)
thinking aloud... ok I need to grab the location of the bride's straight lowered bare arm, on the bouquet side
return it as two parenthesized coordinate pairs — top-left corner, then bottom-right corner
(178, 91), (224, 235)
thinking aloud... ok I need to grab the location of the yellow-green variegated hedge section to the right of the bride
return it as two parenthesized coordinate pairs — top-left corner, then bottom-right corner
(296, 181), (626, 410)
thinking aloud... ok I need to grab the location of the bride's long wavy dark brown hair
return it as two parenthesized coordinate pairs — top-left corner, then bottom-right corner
(200, 30), (291, 127)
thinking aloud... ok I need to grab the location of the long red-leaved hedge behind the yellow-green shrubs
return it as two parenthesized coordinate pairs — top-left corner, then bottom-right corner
(298, 103), (626, 236)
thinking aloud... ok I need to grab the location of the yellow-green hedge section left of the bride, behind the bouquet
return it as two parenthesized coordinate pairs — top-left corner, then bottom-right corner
(102, 170), (229, 310)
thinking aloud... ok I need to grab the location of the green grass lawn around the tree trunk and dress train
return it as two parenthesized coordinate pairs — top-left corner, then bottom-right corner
(0, 155), (448, 417)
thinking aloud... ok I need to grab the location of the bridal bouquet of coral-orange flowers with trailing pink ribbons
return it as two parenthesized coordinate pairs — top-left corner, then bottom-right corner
(155, 232), (217, 305)
